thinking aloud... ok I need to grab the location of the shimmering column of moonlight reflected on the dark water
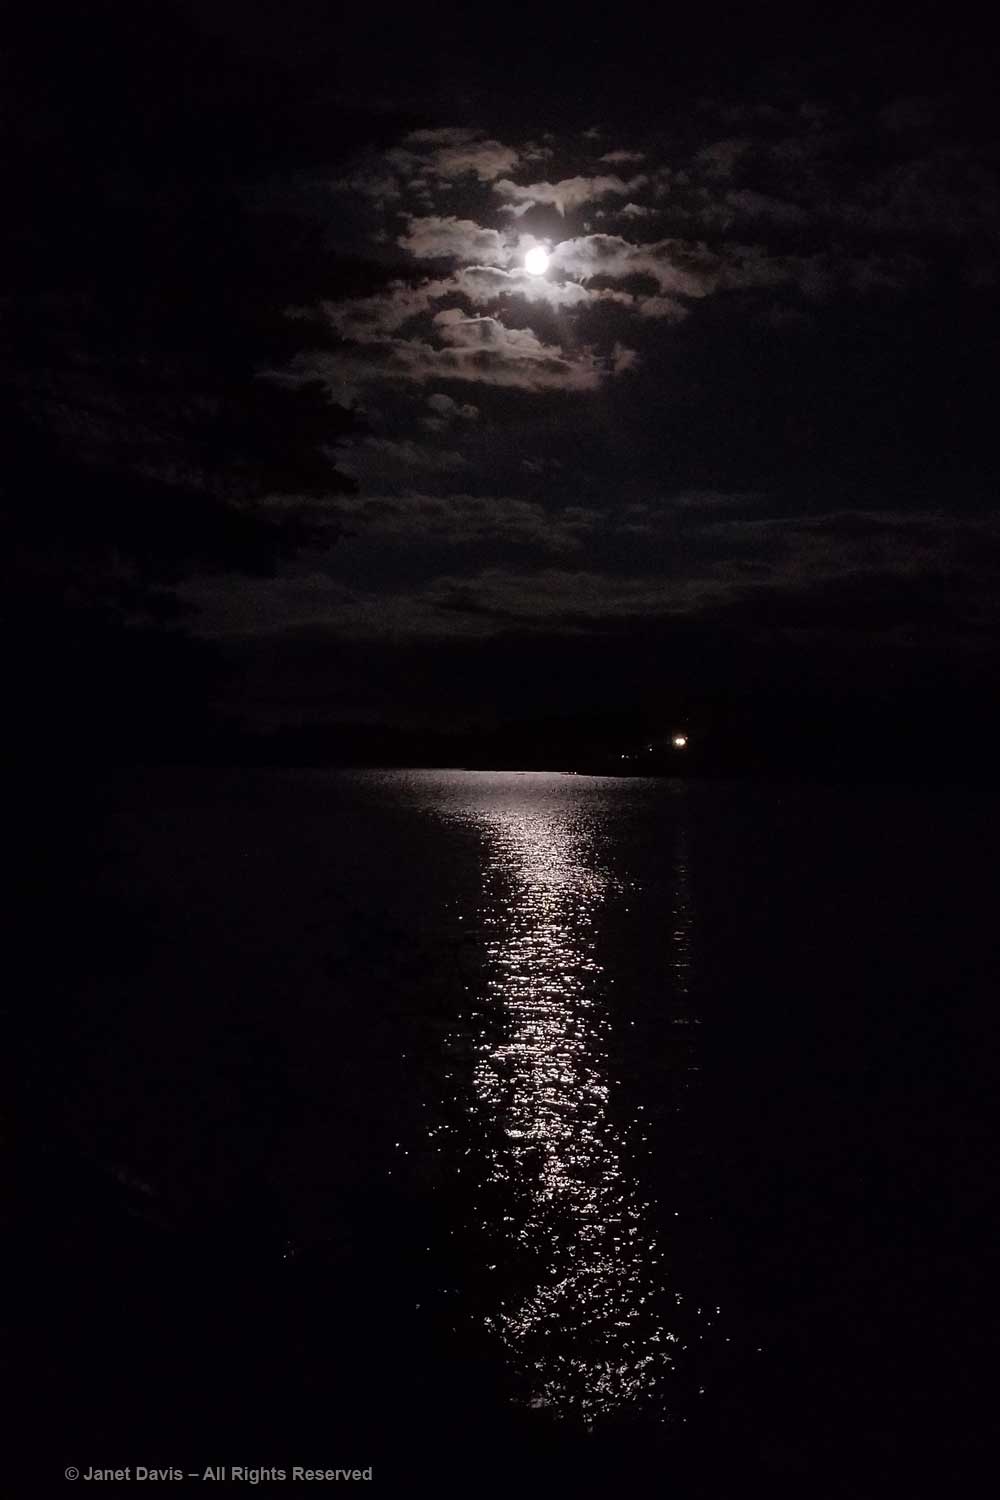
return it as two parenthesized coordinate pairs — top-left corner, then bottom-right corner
(434, 777), (707, 1422)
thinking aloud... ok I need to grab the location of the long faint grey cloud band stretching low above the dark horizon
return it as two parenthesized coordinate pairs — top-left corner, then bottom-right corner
(179, 491), (1000, 645)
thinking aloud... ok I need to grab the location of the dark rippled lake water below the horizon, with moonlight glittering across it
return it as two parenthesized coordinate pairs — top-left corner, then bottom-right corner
(27, 771), (996, 1494)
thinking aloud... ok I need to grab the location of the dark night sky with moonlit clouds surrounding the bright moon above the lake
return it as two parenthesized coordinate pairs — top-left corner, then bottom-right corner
(9, 0), (1000, 738)
